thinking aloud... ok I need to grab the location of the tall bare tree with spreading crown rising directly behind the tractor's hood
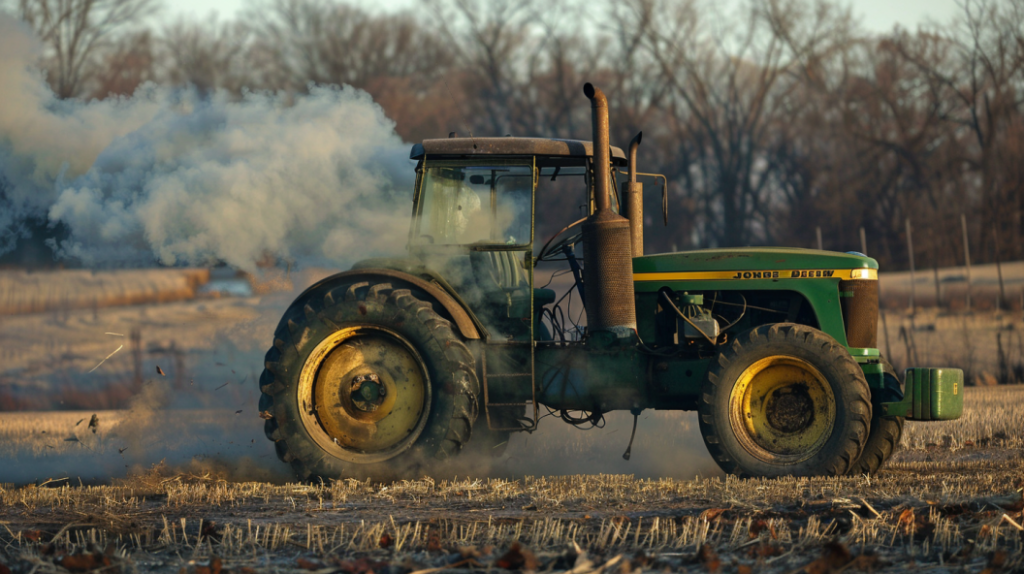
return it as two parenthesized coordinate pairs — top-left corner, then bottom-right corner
(628, 0), (849, 246)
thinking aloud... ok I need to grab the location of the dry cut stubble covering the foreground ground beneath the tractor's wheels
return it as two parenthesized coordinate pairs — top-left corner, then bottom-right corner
(0, 388), (1024, 574)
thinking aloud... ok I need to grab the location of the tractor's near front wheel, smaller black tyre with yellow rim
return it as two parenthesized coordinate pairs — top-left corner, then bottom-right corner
(697, 323), (871, 477)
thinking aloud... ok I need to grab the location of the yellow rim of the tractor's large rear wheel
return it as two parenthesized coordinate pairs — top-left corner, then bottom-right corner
(298, 325), (430, 462)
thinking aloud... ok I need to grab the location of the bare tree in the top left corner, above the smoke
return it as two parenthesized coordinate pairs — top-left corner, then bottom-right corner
(18, 0), (157, 98)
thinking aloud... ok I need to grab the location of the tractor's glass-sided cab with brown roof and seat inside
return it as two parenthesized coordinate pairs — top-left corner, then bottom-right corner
(409, 137), (627, 341)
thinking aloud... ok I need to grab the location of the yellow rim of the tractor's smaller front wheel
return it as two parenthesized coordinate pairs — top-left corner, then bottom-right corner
(729, 355), (836, 463)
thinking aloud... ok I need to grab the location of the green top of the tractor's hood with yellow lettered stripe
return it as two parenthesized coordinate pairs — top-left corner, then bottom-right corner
(633, 248), (879, 278)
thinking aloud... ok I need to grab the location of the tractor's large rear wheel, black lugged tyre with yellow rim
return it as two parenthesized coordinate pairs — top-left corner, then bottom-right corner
(260, 282), (478, 480)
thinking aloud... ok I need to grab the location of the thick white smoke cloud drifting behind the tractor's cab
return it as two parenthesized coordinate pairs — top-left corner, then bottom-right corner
(0, 14), (413, 270)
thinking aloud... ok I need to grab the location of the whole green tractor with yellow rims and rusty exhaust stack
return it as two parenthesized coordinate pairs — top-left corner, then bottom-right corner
(259, 84), (964, 479)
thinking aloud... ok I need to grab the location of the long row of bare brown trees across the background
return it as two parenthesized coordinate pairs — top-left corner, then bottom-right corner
(8, 0), (1024, 268)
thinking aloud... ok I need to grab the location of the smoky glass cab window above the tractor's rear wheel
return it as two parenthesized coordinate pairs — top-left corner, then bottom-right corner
(413, 165), (534, 246)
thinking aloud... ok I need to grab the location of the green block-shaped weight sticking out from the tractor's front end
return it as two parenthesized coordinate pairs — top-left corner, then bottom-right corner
(881, 367), (964, 421)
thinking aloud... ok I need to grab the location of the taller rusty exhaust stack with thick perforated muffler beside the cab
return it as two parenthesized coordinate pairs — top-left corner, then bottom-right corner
(583, 83), (637, 339)
